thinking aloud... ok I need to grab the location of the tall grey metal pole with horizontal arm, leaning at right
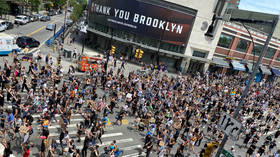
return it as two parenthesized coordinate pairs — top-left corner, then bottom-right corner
(216, 16), (279, 157)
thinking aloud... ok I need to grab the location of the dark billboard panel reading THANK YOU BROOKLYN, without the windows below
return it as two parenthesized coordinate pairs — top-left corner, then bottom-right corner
(89, 0), (195, 45)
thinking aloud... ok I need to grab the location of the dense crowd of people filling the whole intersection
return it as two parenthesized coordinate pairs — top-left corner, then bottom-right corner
(0, 47), (280, 157)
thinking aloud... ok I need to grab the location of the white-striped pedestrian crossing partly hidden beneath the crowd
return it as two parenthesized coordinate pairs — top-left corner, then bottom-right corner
(3, 105), (145, 157)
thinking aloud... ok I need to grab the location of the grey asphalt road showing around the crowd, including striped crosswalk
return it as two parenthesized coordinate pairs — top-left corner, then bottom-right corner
(0, 15), (280, 157)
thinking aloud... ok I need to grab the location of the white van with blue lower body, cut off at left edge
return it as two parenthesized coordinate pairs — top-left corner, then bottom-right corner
(0, 33), (19, 56)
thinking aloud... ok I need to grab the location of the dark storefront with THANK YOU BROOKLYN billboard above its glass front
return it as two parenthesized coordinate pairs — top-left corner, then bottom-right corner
(88, 0), (197, 70)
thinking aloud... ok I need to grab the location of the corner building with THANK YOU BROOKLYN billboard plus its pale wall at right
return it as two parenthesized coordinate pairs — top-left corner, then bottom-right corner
(86, 0), (225, 73)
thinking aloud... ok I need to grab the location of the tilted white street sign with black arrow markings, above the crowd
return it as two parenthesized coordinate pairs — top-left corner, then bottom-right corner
(218, 113), (242, 138)
